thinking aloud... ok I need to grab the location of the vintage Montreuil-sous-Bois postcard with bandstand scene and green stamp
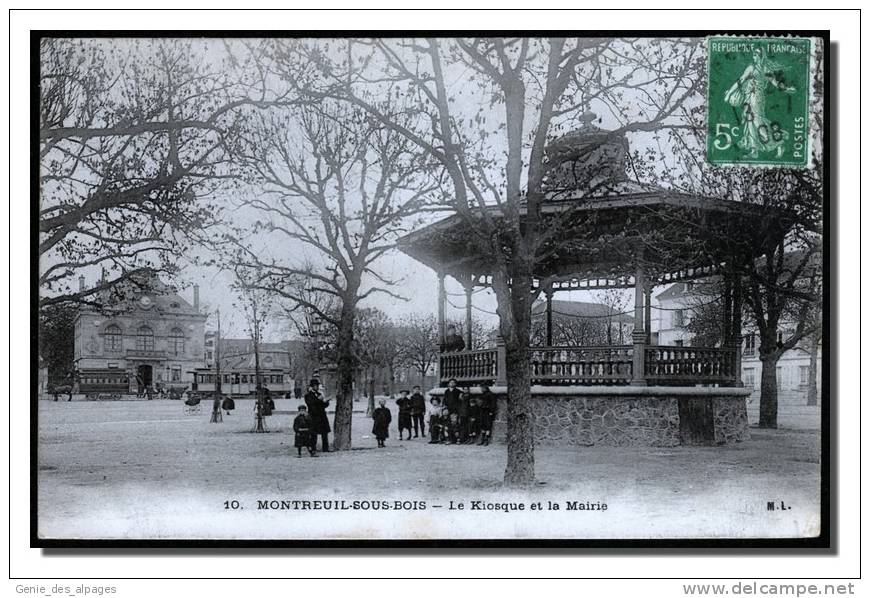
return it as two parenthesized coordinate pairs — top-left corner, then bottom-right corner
(31, 31), (831, 547)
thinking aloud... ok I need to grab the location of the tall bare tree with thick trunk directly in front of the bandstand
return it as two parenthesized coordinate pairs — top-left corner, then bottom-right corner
(275, 38), (701, 485)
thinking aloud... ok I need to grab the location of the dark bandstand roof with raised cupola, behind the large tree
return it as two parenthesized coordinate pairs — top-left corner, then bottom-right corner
(397, 123), (793, 288)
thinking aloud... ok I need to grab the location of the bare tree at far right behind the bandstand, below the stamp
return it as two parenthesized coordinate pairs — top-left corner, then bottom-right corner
(633, 42), (825, 428)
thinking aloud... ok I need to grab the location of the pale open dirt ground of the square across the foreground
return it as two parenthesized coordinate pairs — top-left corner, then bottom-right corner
(38, 400), (820, 539)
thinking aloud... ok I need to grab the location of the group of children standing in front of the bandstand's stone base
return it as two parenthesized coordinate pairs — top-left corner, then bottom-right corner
(372, 378), (497, 447)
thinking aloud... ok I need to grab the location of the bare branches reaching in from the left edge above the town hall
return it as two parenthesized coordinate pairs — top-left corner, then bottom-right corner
(39, 38), (258, 305)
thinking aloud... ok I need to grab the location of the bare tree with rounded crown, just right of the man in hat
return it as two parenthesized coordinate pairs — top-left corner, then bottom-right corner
(235, 101), (435, 450)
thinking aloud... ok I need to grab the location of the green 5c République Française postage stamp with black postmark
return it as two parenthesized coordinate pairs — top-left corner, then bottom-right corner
(707, 37), (813, 168)
